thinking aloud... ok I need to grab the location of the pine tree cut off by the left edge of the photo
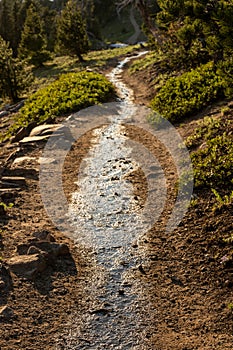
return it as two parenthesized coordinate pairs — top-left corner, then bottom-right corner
(0, 36), (33, 102)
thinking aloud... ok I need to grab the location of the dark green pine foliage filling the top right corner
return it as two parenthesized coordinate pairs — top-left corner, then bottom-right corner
(157, 0), (233, 64)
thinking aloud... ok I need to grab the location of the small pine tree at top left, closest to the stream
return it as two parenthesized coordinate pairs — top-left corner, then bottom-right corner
(58, 0), (89, 62)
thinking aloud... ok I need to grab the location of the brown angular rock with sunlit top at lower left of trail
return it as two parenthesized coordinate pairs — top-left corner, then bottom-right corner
(7, 254), (47, 279)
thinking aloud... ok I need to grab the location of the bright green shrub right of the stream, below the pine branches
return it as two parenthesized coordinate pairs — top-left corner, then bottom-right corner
(151, 62), (224, 122)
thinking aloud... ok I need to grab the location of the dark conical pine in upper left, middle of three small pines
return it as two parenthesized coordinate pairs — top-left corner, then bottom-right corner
(19, 4), (50, 66)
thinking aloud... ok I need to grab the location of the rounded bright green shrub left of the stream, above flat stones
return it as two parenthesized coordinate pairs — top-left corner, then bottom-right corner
(10, 71), (114, 129)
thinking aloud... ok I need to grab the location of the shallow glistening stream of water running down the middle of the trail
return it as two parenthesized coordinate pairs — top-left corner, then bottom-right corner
(55, 53), (163, 350)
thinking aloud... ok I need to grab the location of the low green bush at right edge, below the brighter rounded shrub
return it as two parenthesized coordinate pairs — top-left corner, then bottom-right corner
(185, 110), (233, 210)
